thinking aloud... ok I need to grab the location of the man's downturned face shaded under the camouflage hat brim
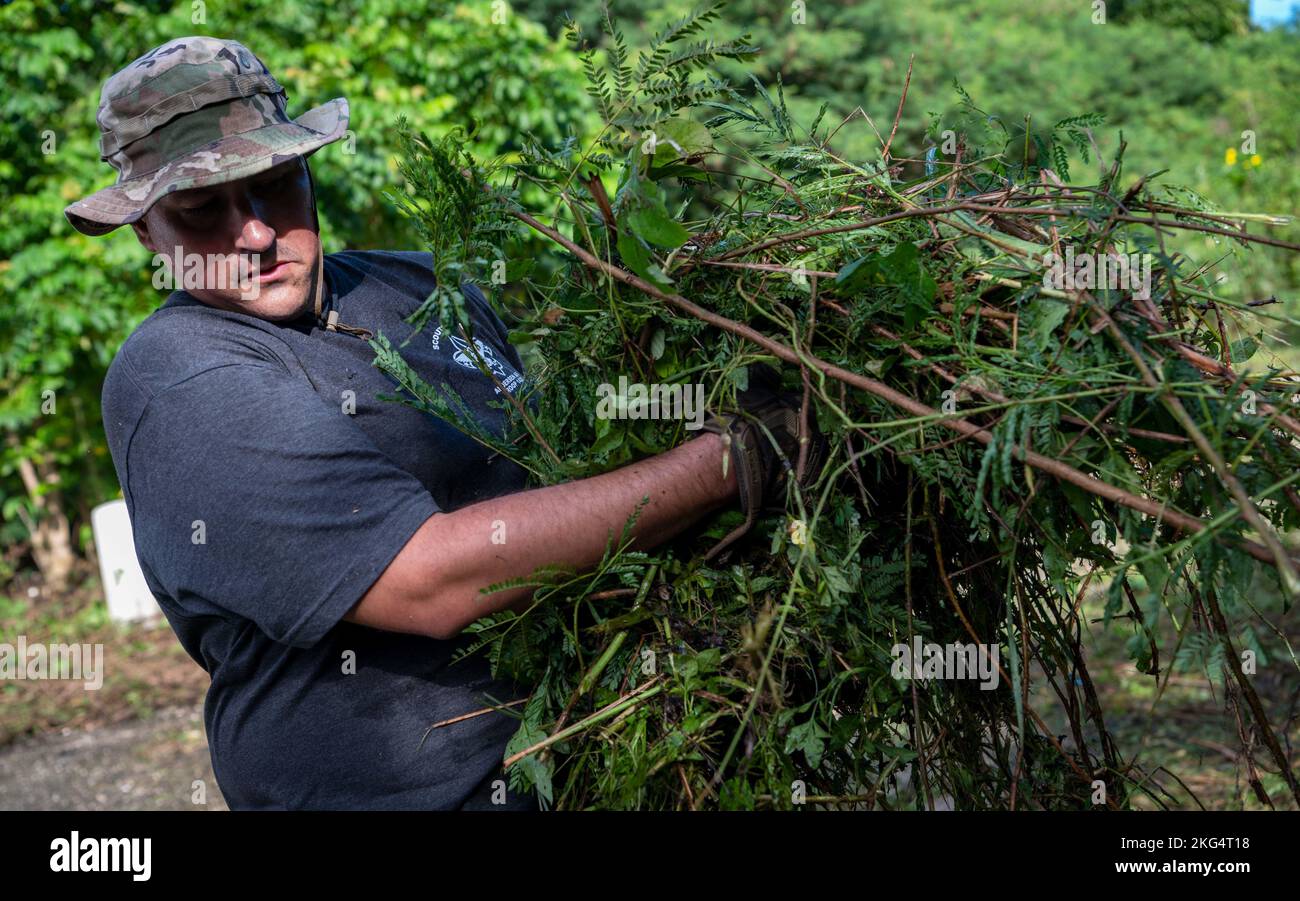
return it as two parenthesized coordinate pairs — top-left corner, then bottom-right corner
(133, 156), (320, 321)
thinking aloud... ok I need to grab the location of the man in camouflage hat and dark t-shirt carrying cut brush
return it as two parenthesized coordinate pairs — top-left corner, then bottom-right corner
(65, 36), (816, 809)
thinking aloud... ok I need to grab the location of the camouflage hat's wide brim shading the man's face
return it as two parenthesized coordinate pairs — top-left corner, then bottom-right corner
(64, 98), (350, 235)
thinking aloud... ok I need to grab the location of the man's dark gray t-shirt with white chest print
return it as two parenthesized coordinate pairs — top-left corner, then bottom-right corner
(103, 251), (536, 809)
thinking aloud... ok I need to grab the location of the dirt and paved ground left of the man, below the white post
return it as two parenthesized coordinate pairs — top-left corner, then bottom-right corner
(0, 561), (226, 810)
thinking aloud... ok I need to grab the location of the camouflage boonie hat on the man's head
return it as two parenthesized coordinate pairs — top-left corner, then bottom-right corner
(64, 36), (348, 235)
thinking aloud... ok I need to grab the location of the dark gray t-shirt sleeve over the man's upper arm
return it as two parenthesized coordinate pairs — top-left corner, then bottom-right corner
(127, 364), (438, 647)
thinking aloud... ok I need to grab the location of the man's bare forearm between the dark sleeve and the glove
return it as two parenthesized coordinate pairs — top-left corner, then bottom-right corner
(355, 433), (737, 636)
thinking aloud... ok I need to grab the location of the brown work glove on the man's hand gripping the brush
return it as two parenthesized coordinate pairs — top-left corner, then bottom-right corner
(703, 364), (827, 560)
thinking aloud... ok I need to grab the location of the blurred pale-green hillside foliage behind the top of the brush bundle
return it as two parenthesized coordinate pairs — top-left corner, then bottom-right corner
(521, 0), (1300, 314)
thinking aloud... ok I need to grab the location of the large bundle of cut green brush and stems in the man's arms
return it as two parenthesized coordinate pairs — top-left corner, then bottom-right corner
(376, 8), (1300, 809)
